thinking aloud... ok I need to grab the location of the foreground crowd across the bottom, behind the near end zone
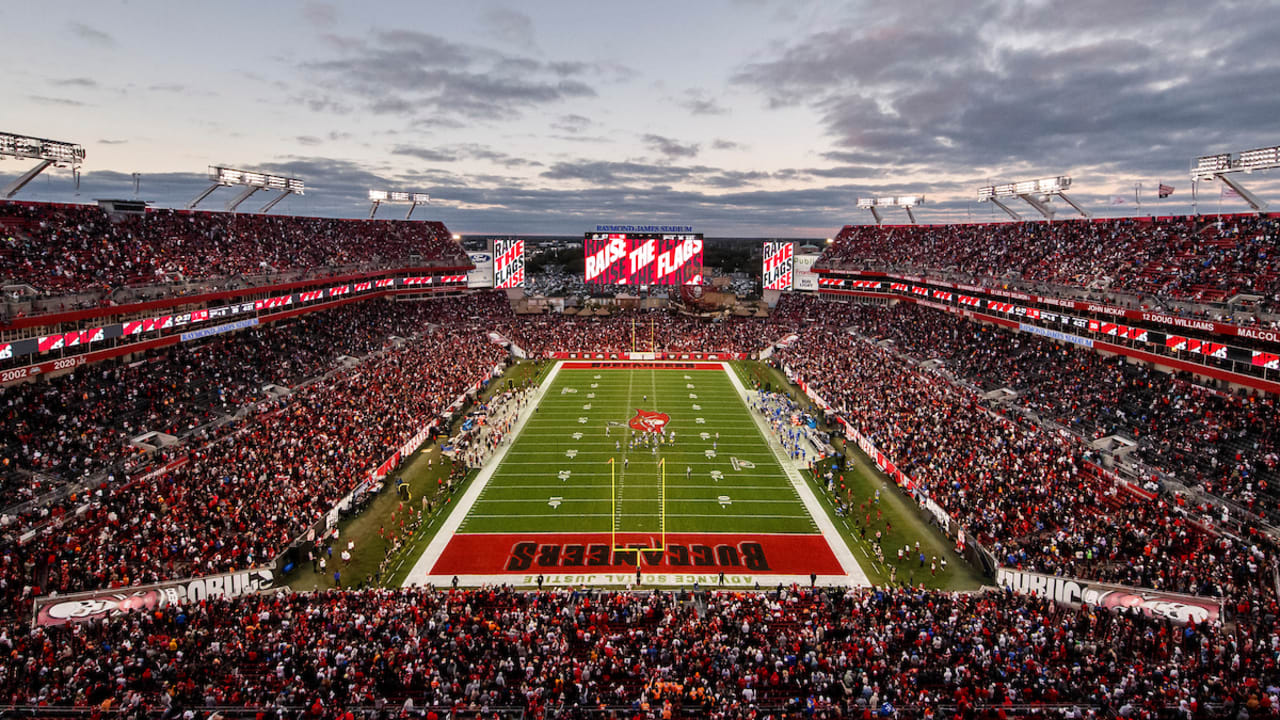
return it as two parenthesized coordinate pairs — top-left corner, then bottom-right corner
(0, 588), (1280, 720)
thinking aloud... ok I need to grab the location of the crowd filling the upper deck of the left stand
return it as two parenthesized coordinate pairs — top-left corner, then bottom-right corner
(0, 202), (467, 293)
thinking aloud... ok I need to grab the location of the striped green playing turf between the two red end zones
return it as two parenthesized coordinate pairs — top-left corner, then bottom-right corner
(460, 368), (817, 533)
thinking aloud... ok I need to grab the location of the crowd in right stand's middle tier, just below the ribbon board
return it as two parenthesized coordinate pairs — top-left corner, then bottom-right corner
(793, 302), (1280, 518)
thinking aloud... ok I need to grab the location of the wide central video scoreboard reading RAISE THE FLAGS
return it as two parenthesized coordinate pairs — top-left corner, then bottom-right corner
(582, 232), (703, 284)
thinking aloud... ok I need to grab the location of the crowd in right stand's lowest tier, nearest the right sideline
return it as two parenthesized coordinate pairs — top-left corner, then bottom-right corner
(776, 295), (1275, 597)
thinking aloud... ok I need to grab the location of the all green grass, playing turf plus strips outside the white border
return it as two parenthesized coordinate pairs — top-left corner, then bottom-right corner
(291, 361), (982, 589)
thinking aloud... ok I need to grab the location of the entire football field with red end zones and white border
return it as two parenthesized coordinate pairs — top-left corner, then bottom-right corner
(407, 361), (865, 585)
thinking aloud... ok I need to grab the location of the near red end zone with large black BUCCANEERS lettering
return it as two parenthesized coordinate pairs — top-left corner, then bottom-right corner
(430, 533), (845, 575)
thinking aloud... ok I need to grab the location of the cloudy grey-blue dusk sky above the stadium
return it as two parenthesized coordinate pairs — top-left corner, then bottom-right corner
(0, 0), (1280, 237)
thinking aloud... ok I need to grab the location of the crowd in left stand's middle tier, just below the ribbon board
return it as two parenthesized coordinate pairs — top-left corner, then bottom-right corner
(0, 301), (471, 497)
